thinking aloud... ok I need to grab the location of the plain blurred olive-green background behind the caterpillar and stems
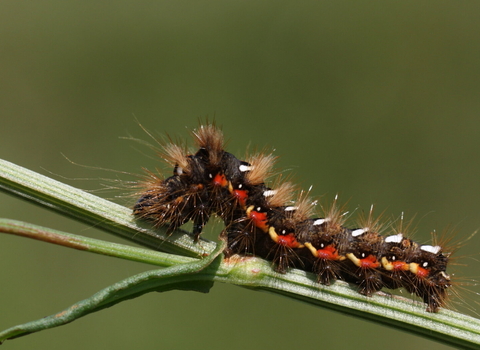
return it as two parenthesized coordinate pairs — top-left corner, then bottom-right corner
(0, 1), (480, 350)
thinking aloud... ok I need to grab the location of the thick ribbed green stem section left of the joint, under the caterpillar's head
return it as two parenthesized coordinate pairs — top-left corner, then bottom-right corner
(0, 159), (215, 257)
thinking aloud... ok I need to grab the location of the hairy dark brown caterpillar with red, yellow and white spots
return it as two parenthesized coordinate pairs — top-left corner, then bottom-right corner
(133, 122), (452, 312)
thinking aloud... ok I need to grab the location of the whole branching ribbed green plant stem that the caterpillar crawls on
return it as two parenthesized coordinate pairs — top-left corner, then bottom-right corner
(0, 161), (480, 349)
